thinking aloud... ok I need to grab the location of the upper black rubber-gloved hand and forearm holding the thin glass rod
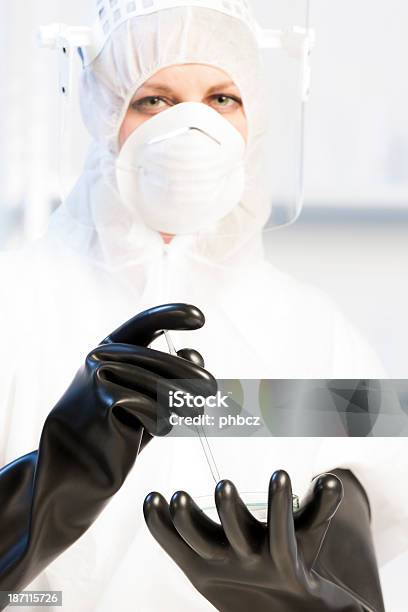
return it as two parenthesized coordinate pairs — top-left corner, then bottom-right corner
(0, 304), (216, 591)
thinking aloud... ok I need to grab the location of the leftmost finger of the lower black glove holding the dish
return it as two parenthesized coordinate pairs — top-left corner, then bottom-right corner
(143, 493), (195, 569)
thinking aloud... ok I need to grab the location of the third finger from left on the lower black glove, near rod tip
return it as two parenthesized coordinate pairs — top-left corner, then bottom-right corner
(215, 480), (265, 557)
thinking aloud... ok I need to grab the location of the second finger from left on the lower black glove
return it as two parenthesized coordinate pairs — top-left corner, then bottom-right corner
(170, 491), (228, 559)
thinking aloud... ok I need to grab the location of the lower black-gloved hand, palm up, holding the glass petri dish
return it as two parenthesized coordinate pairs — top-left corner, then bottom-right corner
(144, 471), (383, 612)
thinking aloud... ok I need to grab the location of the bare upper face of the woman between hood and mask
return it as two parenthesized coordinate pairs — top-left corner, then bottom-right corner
(119, 64), (248, 148)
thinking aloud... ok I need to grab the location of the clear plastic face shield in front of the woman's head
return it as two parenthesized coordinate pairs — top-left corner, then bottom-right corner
(42, 0), (312, 260)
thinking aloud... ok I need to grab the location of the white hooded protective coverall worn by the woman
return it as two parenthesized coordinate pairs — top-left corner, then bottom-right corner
(0, 2), (408, 612)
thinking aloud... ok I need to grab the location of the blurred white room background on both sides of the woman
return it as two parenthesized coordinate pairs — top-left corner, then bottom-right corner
(0, 0), (408, 377)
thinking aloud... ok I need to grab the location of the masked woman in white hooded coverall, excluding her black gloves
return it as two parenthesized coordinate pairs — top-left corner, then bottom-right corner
(0, 0), (408, 612)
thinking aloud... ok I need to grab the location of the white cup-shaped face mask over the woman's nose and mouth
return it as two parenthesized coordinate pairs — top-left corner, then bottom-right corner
(116, 102), (245, 234)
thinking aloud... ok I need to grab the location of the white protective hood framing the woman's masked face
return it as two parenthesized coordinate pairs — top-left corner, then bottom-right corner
(52, 2), (270, 278)
